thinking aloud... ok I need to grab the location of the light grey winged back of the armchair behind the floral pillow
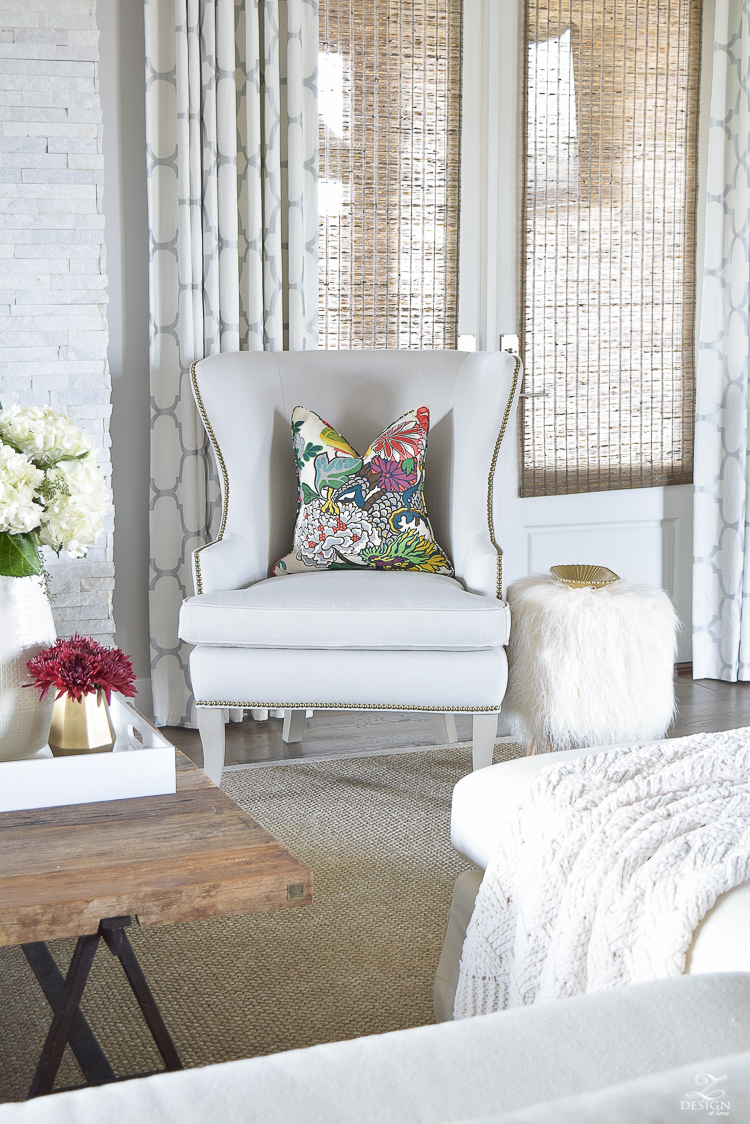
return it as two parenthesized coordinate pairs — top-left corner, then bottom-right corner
(188, 351), (519, 580)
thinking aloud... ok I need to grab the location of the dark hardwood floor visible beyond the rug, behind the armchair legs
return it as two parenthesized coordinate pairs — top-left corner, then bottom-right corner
(163, 674), (750, 765)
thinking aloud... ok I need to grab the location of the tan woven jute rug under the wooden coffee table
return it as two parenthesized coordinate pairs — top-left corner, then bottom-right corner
(0, 743), (523, 1100)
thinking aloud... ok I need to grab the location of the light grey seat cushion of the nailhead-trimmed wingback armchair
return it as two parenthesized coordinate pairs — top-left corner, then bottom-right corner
(180, 570), (510, 652)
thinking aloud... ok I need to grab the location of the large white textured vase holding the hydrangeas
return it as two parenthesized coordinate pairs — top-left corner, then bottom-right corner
(0, 574), (56, 761)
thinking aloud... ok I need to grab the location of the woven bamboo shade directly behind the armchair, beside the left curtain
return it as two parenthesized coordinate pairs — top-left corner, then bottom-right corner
(318, 0), (461, 348)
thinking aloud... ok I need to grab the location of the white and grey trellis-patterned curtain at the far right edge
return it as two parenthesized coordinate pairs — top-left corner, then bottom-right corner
(693, 0), (750, 682)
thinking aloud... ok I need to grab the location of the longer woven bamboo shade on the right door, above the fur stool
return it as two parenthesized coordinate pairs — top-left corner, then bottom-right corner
(521, 0), (701, 496)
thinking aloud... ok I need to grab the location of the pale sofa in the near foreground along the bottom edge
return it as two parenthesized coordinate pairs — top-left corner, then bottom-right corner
(0, 973), (750, 1124)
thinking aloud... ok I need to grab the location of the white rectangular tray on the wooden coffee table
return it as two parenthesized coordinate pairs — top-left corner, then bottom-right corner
(0, 692), (177, 812)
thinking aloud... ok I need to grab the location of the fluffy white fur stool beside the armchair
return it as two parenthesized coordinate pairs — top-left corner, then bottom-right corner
(503, 574), (678, 753)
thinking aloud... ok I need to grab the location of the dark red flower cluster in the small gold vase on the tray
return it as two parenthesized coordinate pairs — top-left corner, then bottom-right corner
(26, 633), (136, 703)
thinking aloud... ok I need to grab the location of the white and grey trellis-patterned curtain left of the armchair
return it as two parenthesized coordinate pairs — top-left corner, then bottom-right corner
(145, 0), (318, 725)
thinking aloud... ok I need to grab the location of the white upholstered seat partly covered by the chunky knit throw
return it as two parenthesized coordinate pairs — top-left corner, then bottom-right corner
(434, 745), (750, 1022)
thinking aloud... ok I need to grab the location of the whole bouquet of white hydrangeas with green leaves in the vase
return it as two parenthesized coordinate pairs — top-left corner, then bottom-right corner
(0, 406), (109, 578)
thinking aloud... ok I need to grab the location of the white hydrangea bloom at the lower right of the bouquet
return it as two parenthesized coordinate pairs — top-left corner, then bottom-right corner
(39, 459), (109, 558)
